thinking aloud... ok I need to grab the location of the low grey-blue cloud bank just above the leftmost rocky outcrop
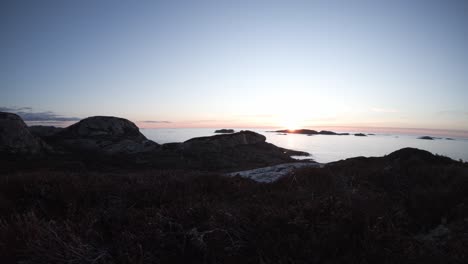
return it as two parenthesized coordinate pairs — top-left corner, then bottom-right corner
(0, 107), (80, 122)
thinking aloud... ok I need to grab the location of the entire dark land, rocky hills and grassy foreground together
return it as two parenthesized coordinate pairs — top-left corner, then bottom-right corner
(0, 113), (468, 264)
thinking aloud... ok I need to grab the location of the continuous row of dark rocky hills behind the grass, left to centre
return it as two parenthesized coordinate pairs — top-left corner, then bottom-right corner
(0, 113), (308, 171)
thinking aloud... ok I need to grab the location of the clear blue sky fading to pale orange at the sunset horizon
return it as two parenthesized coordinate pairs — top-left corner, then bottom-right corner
(0, 0), (468, 130)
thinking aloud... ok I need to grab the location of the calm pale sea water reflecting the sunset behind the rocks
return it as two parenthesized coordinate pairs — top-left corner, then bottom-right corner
(141, 128), (468, 162)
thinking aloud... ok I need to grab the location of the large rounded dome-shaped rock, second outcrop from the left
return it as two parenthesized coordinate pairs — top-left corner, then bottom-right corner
(52, 116), (159, 155)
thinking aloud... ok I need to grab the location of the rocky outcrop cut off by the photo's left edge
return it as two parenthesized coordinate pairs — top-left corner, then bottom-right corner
(0, 112), (49, 155)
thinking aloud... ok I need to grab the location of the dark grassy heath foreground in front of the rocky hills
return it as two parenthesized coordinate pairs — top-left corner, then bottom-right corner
(0, 156), (468, 263)
